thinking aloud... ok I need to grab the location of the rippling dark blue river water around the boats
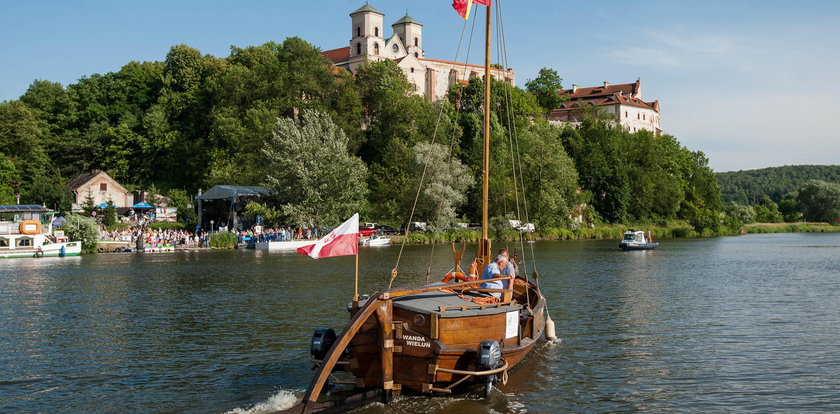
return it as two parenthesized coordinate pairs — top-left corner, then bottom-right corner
(0, 233), (840, 414)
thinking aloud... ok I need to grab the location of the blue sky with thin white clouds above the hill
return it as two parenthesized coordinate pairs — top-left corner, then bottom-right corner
(0, 0), (840, 171)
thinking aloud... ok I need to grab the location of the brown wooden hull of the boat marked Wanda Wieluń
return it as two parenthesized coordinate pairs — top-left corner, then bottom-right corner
(347, 284), (545, 393)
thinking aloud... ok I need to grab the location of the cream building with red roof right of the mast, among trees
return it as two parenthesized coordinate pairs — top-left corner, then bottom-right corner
(548, 79), (662, 134)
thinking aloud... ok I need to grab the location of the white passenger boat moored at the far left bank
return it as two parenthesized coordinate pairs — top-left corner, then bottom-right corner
(0, 204), (82, 258)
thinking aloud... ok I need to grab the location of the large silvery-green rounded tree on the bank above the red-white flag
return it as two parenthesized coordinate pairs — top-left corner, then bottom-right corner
(263, 110), (367, 227)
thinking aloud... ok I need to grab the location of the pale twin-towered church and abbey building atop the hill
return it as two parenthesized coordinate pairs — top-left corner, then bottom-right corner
(322, 4), (515, 102)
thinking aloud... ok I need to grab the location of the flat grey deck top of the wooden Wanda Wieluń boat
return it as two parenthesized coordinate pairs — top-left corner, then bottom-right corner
(394, 284), (522, 318)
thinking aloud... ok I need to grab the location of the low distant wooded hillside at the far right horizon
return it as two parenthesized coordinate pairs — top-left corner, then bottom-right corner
(716, 165), (840, 204)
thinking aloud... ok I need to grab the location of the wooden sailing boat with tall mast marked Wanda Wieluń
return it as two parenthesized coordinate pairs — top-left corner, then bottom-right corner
(285, 2), (554, 413)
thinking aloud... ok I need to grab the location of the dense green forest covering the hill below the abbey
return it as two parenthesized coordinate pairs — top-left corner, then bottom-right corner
(0, 38), (725, 232)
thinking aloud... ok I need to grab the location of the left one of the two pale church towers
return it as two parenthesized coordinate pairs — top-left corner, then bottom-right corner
(349, 3), (385, 73)
